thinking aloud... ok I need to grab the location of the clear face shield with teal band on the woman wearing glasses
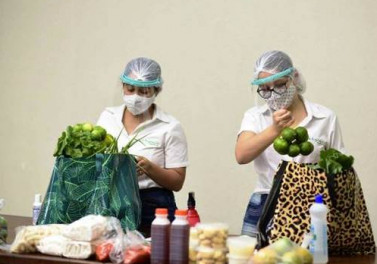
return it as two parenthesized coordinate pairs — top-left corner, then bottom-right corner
(251, 68), (296, 110)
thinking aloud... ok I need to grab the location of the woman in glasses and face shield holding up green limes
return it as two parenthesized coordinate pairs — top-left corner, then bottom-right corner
(235, 51), (344, 236)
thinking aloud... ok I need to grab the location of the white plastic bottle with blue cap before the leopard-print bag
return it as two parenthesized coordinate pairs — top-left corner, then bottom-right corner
(309, 194), (328, 263)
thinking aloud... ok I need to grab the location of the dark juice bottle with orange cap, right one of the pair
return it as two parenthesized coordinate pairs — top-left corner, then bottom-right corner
(169, 210), (190, 264)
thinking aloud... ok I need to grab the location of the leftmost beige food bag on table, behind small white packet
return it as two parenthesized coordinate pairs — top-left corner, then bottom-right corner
(10, 224), (67, 253)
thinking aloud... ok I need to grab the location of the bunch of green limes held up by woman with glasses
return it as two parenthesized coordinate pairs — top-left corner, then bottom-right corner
(273, 127), (314, 157)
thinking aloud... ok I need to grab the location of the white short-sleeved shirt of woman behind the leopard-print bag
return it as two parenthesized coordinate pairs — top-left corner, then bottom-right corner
(238, 98), (345, 193)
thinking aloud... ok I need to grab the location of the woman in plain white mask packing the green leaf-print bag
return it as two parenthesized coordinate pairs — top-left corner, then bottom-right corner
(97, 58), (188, 236)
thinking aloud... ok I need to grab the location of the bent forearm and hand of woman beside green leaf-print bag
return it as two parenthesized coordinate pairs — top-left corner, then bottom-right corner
(137, 156), (186, 192)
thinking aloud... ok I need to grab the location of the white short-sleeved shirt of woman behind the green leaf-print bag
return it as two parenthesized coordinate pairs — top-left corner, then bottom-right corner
(97, 104), (188, 189)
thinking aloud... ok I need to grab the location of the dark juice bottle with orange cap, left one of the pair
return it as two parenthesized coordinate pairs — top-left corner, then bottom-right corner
(151, 208), (170, 264)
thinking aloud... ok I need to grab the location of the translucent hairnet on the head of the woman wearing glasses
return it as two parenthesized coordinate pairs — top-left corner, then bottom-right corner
(254, 50), (306, 93)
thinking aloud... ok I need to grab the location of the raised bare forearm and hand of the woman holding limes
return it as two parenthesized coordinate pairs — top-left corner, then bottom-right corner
(235, 109), (294, 164)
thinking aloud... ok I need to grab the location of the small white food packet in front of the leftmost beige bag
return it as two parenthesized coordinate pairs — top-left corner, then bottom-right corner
(37, 235), (70, 256)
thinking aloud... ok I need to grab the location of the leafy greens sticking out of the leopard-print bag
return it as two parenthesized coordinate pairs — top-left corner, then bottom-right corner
(314, 148), (354, 174)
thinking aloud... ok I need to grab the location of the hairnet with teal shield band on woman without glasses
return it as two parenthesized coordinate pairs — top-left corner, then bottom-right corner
(120, 57), (163, 89)
